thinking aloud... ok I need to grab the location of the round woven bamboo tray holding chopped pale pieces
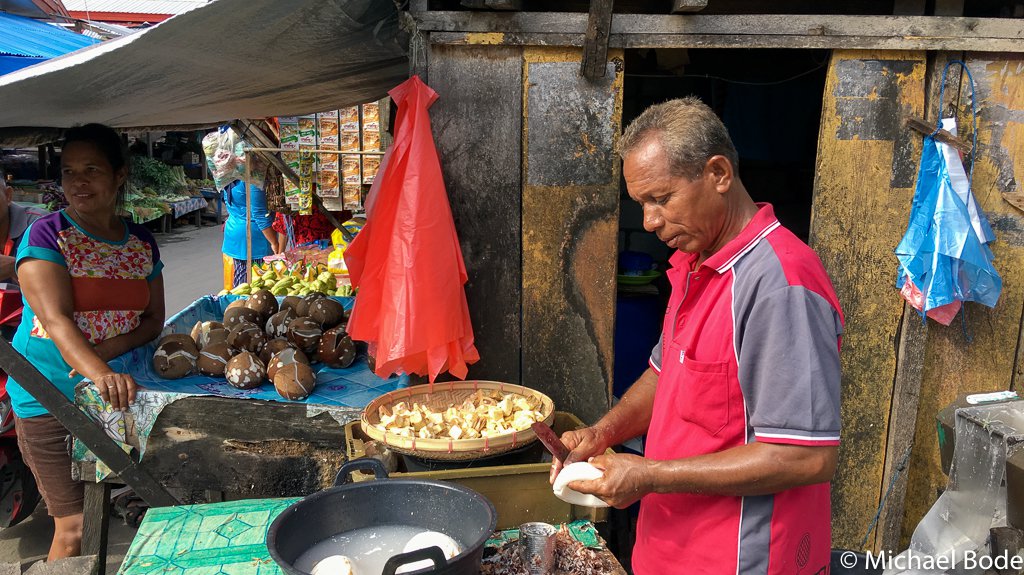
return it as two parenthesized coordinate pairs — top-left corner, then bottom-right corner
(360, 381), (555, 461)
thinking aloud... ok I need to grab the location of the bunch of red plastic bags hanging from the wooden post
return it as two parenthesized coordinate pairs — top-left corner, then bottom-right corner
(345, 76), (480, 382)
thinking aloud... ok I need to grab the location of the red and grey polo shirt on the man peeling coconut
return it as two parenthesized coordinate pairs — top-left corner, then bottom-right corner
(633, 205), (843, 575)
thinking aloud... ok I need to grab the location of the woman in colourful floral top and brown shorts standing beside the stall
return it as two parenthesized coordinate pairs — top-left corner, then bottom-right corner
(7, 124), (164, 561)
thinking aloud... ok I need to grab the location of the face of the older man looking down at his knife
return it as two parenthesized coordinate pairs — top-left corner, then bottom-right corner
(623, 138), (726, 253)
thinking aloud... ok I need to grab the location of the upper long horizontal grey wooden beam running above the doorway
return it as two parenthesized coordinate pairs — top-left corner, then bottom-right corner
(415, 11), (1024, 42)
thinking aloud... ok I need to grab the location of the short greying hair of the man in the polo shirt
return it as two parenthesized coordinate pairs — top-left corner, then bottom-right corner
(617, 96), (739, 180)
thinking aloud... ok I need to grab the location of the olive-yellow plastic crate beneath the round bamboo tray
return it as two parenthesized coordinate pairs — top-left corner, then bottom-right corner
(345, 411), (611, 529)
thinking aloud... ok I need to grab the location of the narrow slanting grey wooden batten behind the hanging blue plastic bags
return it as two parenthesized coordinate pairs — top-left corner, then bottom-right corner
(873, 52), (970, 551)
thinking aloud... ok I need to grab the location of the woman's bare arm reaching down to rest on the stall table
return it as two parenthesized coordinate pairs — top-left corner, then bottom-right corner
(17, 259), (143, 409)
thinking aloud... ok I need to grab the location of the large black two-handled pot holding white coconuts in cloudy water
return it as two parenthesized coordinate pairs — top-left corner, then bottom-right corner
(266, 457), (498, 575)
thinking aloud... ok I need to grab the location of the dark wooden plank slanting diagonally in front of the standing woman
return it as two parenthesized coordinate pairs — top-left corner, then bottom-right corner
(0, 338), (178, 507)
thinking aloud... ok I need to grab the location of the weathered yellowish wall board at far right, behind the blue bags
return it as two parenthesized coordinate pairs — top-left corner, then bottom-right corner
(903, 54), (1024, 541)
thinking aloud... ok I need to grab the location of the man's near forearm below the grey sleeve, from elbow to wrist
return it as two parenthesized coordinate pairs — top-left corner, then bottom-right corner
(647, 442), (839, 495)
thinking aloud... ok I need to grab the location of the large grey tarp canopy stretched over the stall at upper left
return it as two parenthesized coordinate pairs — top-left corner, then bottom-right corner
(0, 0), (409, 139)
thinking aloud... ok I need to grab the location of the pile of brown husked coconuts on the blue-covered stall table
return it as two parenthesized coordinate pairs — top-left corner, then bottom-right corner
(153, 290), (355, 399)
